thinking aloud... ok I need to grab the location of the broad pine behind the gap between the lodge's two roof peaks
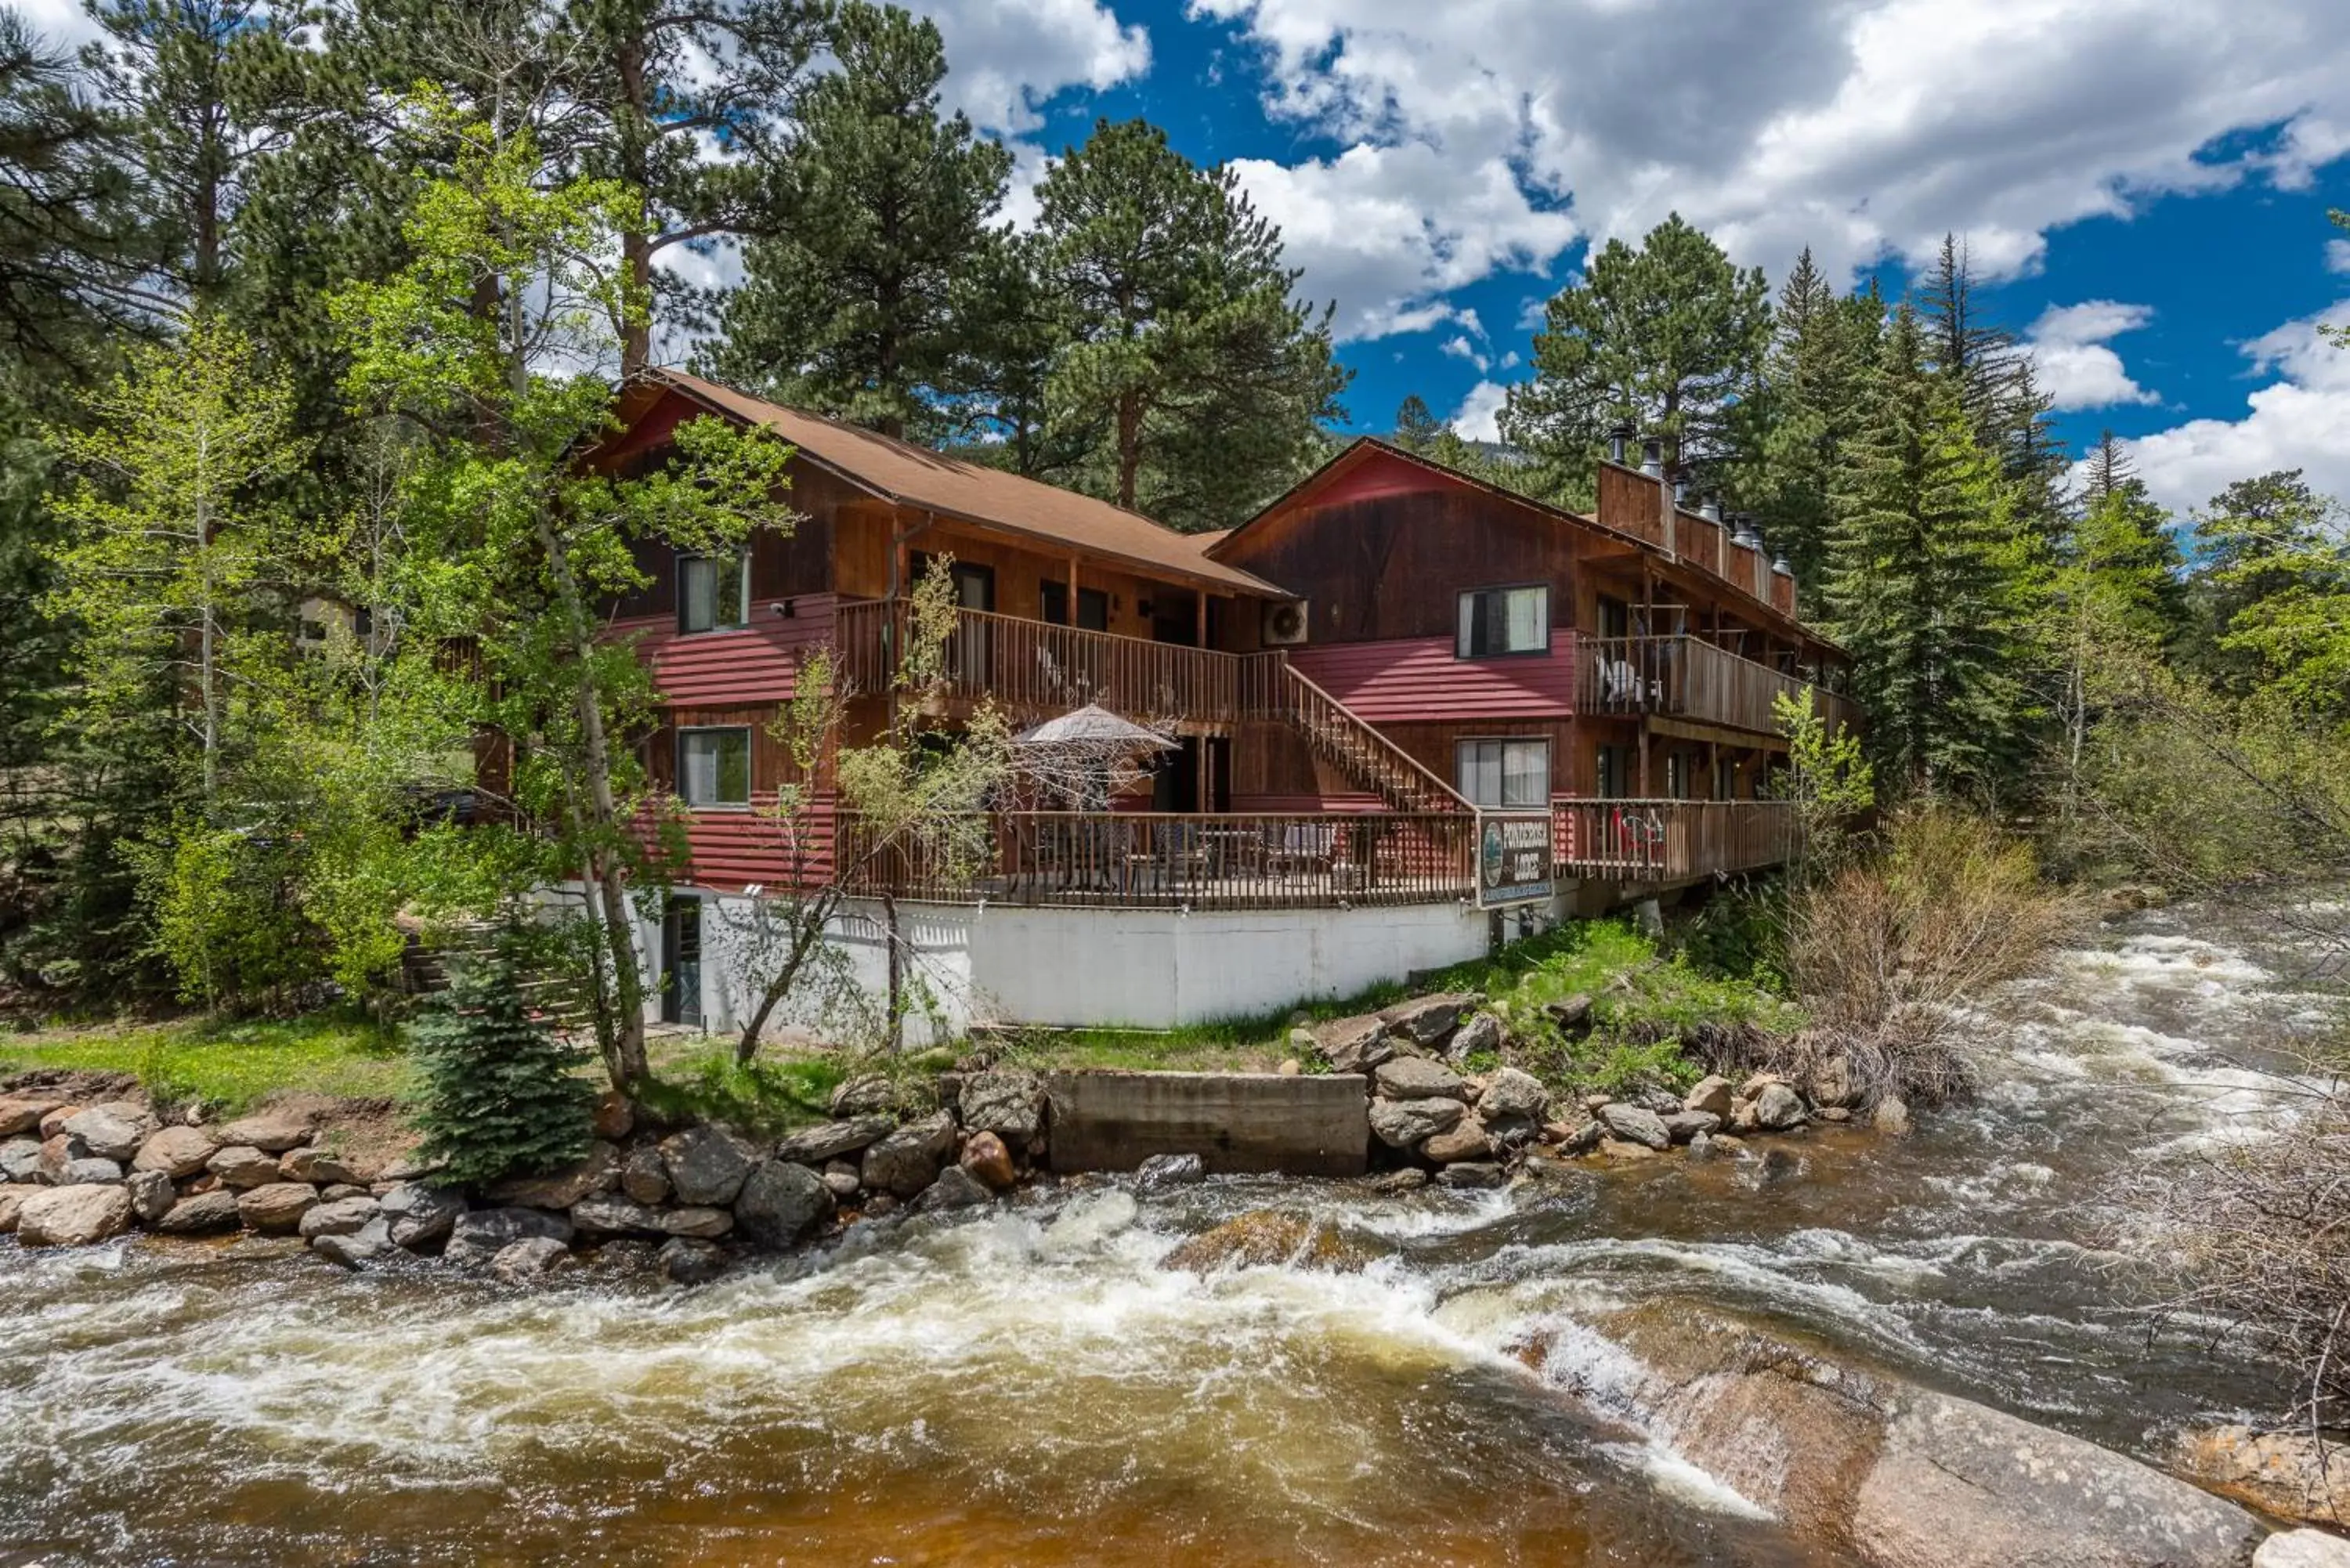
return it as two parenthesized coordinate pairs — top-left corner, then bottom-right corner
(1036, 120), (1347, 529)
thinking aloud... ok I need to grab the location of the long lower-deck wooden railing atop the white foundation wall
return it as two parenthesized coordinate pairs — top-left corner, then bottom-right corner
(839, 811), (1476, 910)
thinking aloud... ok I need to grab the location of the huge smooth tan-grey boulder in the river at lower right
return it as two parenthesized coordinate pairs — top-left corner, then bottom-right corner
(1598, 1300), (2261, 1568)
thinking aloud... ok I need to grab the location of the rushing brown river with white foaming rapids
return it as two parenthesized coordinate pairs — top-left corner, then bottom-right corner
(0, 910), (2310, 1568)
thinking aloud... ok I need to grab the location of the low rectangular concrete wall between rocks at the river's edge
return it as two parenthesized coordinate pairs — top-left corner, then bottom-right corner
(1046, 1072), (1370, 1176)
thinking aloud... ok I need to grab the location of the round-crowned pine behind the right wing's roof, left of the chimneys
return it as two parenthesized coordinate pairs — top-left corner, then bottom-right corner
(1502, 214), (1770, 503)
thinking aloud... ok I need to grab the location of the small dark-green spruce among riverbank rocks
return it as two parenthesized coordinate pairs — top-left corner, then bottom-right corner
(411, 941), (597, 1183)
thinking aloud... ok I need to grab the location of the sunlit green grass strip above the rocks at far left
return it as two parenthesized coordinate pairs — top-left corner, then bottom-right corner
(0, 1011), (414, 1115)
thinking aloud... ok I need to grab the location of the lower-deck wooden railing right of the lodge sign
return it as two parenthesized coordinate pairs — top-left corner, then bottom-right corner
(1551, 800), (1795, 882)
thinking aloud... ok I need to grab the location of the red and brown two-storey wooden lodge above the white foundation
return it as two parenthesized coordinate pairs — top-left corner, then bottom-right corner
(595, 371), (1852, 926)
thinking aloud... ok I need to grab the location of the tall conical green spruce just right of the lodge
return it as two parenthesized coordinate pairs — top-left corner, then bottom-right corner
(1828, 305), (2033, 790)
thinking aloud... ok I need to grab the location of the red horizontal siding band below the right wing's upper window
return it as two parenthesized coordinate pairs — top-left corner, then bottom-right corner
(1290, 630), (1574, 724)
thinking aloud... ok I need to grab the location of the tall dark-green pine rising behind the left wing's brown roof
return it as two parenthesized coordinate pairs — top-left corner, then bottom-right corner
(714, 0), (1010, 439)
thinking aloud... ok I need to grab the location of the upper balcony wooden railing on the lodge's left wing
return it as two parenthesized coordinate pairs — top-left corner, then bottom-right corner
(839, 599), (1283, 724)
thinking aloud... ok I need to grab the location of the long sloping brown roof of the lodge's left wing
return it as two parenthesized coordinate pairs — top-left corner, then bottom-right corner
(646, 369), (1290, 599)
